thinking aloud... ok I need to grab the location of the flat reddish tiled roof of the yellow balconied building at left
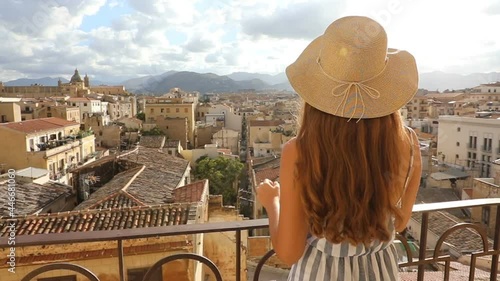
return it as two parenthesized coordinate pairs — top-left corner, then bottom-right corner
(0, 117), (80, 134)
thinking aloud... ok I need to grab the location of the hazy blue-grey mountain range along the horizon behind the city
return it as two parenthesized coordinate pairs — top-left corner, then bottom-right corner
(1, 70), (500, 94)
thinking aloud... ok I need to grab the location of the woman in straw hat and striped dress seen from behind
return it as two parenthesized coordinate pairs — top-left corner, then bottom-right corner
(257, 16), (421, 281)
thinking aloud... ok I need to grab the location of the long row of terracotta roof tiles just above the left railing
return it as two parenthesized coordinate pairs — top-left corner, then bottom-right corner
(0, 204), (196, 237)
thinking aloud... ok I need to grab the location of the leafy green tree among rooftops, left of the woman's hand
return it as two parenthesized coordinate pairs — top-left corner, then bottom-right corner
(194, 156), (243, 203)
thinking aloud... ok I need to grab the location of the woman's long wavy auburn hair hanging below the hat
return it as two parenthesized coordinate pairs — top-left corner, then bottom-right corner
(294, 103), (409, 244)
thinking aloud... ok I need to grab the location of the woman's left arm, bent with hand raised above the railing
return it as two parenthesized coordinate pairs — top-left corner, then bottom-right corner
(257, 139), (308, 265)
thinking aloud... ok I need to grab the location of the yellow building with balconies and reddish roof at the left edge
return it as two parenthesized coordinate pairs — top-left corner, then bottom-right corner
(0, 117), (95, 179)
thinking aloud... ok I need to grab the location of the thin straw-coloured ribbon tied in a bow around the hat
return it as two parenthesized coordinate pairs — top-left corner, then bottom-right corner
(316, 57), (388, 123)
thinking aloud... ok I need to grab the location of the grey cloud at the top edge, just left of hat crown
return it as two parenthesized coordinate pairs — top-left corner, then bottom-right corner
(242, 1), (342, 39)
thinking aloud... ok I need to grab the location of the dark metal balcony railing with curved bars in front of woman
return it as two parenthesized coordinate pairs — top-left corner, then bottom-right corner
(0, 198), (500, 281)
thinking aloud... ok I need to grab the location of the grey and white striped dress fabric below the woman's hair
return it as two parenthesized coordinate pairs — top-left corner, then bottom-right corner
(288, 223), (399, 281)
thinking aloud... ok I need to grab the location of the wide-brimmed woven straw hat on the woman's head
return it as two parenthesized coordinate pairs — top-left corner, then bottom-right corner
(286, 16), (418, 121)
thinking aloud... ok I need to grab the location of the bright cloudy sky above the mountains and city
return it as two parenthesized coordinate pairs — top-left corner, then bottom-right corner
(0, 0), (500, 82)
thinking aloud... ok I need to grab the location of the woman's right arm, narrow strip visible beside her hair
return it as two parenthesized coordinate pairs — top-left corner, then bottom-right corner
(395, 130), (422, 232)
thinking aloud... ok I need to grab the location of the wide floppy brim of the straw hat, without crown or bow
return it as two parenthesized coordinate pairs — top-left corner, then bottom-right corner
(286, 36), (418, 119)
